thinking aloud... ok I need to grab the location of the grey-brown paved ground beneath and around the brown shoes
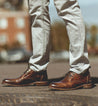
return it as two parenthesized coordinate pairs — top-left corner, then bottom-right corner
(0, 58), (98, 106)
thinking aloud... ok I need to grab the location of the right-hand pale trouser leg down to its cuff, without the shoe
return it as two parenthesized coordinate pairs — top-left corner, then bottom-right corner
(55, 0), (90, 74)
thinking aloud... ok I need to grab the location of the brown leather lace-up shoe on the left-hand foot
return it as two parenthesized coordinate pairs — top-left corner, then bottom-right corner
(2, 69), (48, 86)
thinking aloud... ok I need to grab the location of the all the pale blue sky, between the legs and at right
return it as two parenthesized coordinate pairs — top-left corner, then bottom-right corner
(49, 0), (98, 25)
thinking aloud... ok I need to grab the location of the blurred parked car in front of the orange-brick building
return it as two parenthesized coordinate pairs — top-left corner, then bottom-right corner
(0, 48), (32, 62)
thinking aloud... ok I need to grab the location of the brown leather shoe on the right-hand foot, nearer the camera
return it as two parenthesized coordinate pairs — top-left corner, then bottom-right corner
(49, 71), (93, 90)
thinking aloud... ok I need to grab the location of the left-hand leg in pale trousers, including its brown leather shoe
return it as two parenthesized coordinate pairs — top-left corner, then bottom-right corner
(2, 0), (50, 86)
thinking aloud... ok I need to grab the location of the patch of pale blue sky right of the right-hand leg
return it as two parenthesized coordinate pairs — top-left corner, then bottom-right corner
(78, 0), (98, 26)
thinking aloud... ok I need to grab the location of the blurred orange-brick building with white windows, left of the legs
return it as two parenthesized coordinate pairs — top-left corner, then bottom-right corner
(0, 0), (32, 50)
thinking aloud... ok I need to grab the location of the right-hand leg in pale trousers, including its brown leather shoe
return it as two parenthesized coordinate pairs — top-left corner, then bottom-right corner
(50, 0), (92, 90)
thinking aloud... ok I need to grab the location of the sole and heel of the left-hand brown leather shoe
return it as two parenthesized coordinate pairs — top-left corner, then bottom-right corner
(3, 81), (48, 87)
